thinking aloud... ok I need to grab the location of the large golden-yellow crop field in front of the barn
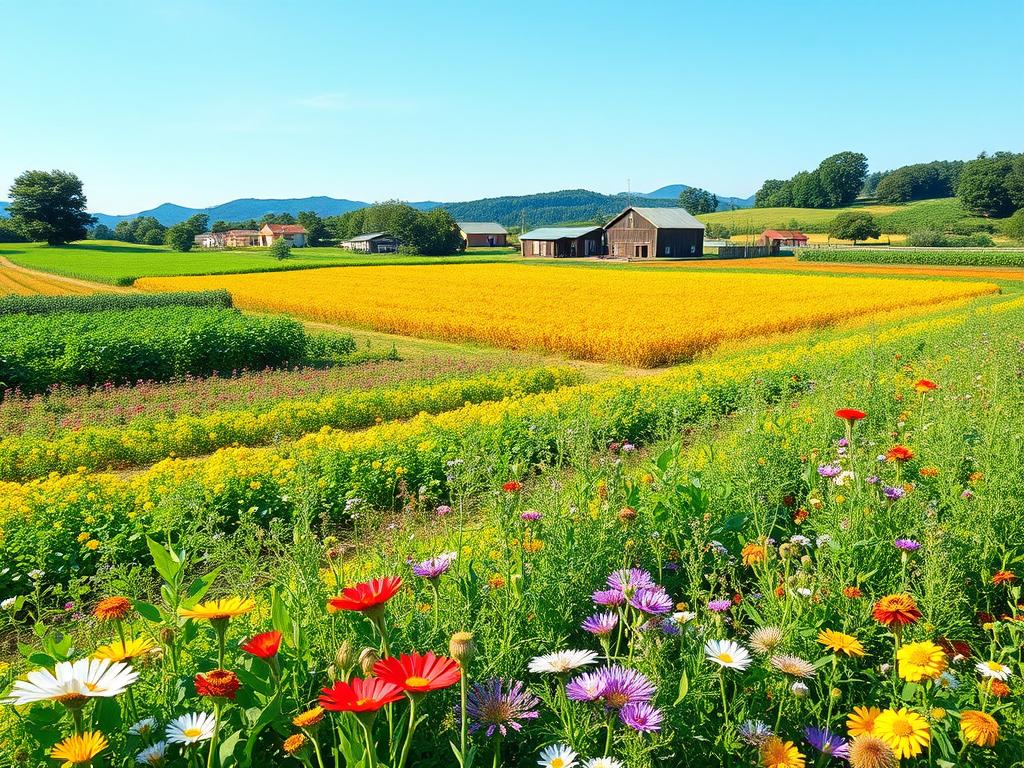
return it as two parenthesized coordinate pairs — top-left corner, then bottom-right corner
(136, 264), (998, 368)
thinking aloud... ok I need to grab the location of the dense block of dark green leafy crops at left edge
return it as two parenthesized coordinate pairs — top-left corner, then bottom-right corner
(0, 306), (306, 393)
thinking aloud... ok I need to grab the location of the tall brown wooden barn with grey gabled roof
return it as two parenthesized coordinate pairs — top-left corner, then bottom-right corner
(604, 206), (705, 259)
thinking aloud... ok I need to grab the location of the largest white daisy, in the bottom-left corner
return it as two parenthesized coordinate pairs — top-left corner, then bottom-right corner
(4, 658), (138, 706)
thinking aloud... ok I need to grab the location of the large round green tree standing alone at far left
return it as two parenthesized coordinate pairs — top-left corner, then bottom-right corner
(7, 170), (96, 246)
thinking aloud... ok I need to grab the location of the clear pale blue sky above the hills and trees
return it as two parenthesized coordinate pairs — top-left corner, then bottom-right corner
(0, 0), (1024, 213)
